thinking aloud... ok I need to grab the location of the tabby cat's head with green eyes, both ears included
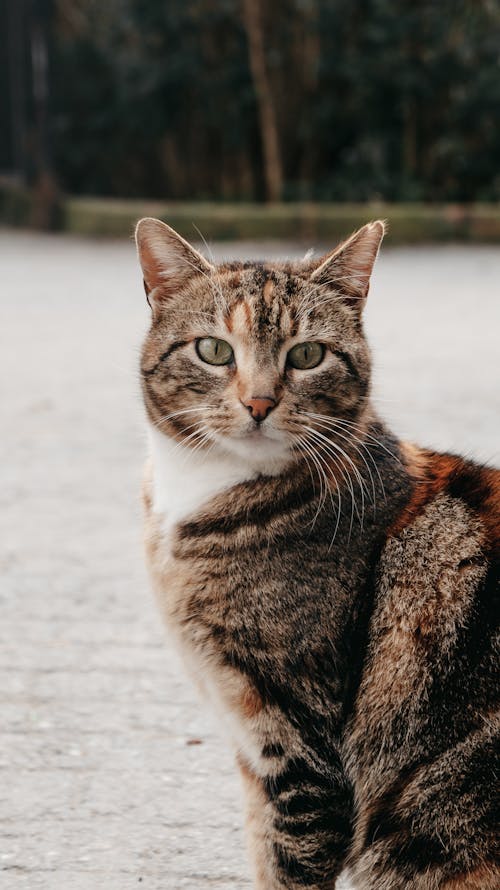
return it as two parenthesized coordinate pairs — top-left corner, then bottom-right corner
(137, 219), (384, 465)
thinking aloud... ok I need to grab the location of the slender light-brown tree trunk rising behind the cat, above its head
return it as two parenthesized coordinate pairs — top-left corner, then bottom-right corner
(243, 0), (283, 201)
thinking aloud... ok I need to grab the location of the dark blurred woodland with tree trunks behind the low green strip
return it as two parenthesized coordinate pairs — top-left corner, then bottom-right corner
(0, 0), (500, 210)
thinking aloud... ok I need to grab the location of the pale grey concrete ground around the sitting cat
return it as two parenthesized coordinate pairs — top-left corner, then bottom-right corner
(0, 232), (500, 890)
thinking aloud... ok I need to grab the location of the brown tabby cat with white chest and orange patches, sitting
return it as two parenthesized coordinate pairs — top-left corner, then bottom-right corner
(137, 219), (500, 890)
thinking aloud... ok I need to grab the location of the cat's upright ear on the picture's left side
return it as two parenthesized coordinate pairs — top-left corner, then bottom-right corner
(135, 217), (213, 310)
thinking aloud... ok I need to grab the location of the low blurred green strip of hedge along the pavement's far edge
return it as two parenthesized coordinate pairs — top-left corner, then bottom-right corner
(0, 185), (500, 245)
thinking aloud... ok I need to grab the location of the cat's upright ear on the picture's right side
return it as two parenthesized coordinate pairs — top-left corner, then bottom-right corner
(311, 219), (386, 312)
